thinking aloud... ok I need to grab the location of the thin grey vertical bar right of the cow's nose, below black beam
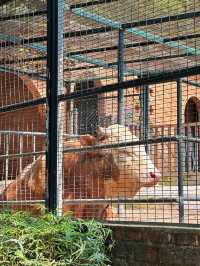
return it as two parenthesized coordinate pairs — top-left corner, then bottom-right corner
(177, 79), (184, 223)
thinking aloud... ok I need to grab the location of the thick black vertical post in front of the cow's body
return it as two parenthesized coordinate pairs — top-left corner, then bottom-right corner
(46, 0), (62, 213)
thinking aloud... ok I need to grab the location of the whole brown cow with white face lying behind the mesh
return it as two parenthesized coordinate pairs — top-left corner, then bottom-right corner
(0, 125), (160, 218)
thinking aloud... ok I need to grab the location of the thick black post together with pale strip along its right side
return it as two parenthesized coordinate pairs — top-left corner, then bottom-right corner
(46, 0), (64, 214)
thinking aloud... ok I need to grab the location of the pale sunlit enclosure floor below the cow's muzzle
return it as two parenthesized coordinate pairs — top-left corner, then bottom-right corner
(112, 185), (200, 224)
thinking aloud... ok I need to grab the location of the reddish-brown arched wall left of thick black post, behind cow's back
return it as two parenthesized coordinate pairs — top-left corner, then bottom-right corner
(0, 73), (46, 180)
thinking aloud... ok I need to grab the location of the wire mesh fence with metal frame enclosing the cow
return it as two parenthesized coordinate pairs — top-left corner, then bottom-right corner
(0, 0), (200, 224)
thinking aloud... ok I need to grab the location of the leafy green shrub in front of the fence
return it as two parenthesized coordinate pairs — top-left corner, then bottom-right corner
(0, 211), (112, 266)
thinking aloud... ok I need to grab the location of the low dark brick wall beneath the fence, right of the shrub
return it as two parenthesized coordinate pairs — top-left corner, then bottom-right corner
(111, 225), (200, 266)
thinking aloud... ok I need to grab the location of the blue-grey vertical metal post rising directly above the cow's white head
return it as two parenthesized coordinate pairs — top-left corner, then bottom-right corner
(118, 30), (125, 125)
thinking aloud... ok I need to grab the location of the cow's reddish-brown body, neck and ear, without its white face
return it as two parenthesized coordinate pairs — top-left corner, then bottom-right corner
(1, 135), (119, 218)
